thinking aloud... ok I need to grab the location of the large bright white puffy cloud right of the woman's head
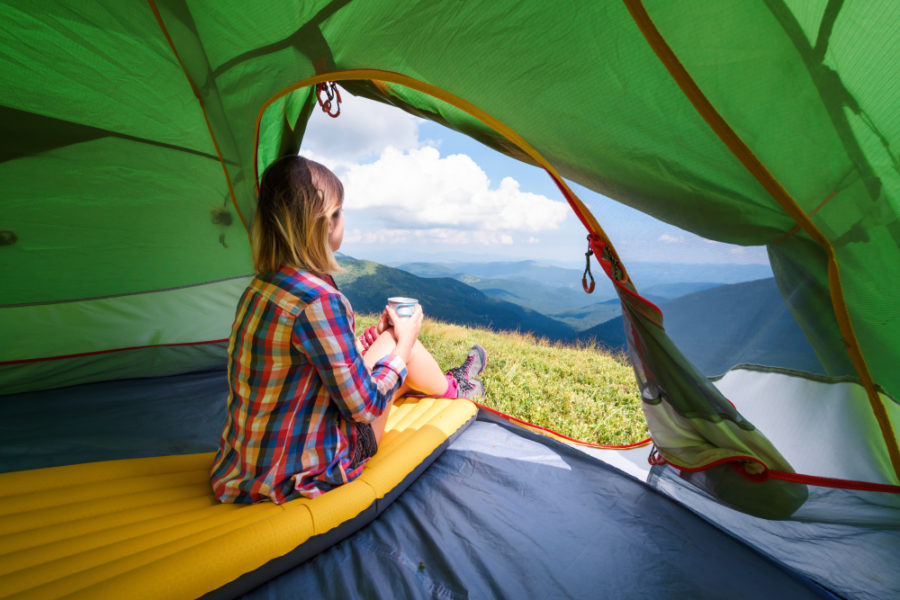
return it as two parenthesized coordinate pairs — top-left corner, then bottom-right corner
(343, 147), (569, 233)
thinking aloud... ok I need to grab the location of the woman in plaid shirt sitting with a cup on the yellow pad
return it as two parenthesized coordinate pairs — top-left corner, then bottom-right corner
(211, 156), (486, 503)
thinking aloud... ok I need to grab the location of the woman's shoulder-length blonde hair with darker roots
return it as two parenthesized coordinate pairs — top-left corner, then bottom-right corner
(252, 156), (344, 274)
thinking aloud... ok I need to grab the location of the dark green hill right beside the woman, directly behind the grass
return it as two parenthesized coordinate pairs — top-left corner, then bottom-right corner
(335, 255), (575, 340)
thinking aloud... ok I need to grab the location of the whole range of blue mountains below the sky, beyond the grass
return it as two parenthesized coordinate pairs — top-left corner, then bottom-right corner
(335, 256), (822, 376)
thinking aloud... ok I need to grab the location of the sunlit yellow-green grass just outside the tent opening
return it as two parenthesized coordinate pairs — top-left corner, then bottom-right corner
(357, 315), (648, 445)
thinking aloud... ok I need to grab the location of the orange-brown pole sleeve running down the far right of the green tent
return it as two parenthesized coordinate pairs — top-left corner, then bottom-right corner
(623, 0), (900, 479)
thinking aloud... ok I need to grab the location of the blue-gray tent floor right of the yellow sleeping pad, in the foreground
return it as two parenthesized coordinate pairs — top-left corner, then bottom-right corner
(245, 421), (830, 600)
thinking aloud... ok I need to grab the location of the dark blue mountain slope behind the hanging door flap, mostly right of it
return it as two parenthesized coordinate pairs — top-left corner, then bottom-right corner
(578, 278), (822, 376)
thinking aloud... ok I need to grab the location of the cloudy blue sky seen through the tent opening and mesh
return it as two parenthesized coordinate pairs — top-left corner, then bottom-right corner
(301, 90), (768, 268)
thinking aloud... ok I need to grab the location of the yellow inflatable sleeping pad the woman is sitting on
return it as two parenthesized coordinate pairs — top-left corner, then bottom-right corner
(0, 398), (477, 599)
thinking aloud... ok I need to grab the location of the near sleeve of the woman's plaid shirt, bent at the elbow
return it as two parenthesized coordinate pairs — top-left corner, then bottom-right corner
(294, 294), (406, 422)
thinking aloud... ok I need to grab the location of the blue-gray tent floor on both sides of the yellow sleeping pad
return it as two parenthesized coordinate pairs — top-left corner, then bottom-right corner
(0, 371), (828, 599)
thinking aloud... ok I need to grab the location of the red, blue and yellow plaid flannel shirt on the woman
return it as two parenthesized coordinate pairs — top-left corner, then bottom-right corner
(211, 267), (406, 504)
